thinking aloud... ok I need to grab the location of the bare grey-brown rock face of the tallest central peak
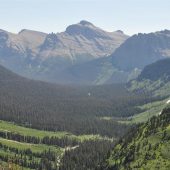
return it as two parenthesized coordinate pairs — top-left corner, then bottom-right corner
(40, 21), (128, 63)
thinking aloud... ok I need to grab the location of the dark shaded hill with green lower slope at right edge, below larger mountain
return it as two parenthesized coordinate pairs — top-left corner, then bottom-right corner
(128, 58), (170, 97)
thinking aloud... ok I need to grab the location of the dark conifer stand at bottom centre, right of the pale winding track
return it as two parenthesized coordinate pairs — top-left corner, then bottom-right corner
(60, 140), (114, 170)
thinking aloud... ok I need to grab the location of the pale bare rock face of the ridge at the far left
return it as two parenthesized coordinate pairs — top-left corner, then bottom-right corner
(0, 30), (46, 58)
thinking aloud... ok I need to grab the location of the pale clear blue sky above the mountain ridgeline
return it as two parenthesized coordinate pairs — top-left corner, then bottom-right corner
(0, 0), (170, 35)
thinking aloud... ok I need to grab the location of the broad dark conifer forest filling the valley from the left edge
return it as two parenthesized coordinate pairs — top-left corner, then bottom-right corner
(0, 64), (149, 137)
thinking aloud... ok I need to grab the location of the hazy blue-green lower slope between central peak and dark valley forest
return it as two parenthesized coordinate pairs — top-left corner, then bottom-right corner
(56, 57), (139, 85)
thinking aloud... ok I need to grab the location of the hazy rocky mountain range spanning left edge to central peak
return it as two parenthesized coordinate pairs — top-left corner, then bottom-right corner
(0, 21), (128, 82)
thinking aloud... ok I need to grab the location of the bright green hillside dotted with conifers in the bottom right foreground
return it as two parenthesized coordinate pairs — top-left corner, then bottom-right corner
(106, 106), (170, 170)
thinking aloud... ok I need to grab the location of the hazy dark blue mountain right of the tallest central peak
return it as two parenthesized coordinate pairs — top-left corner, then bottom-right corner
(111, 30), (170, 71)
